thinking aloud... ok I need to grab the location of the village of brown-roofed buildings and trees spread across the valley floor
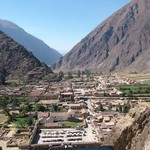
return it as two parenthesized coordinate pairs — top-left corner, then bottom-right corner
(0, 74), (146, 150)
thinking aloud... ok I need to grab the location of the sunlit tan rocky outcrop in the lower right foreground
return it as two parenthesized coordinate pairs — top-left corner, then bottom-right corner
(103, 103), (150, 150)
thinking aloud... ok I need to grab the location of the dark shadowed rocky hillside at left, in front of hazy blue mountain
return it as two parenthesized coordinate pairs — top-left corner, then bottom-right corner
(0, 31), (53, 81)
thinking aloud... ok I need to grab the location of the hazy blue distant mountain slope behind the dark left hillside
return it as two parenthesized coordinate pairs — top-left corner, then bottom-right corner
(0, 20), (62, 65)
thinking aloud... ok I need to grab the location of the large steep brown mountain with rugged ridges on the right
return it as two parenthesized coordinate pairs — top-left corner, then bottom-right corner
(52, 0), (150, 73)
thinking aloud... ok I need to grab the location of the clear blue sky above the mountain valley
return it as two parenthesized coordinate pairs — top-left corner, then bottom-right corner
(0, 0), (130, 54)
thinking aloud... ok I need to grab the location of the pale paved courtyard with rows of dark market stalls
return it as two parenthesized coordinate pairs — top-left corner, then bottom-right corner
(35, 125), (98, 144)
